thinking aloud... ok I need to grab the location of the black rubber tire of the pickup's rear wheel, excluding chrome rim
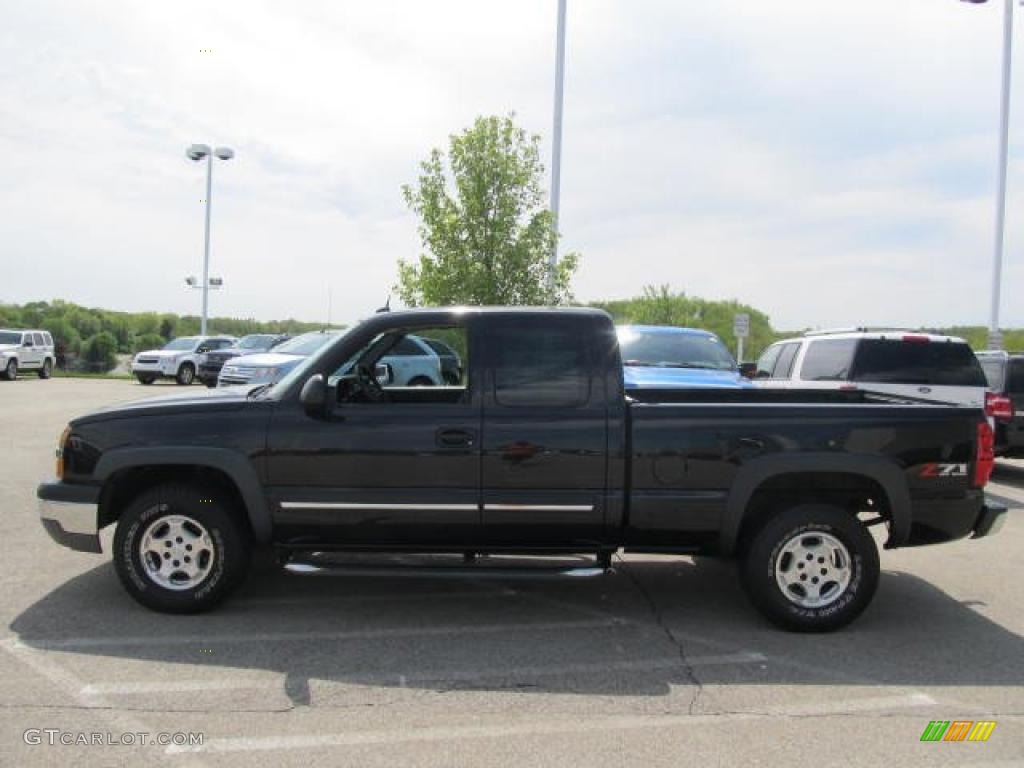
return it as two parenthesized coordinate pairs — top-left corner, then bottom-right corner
(740, 504), (881, 632)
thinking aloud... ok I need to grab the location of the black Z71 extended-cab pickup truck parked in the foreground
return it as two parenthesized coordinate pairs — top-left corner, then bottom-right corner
(38, 308), (1006, 631)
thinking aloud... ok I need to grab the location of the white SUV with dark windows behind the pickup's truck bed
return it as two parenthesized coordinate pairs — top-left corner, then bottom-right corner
(754, 329), (987, 409)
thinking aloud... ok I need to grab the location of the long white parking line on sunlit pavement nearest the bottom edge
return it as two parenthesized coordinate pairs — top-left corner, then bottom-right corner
(165, 693), (935, 755)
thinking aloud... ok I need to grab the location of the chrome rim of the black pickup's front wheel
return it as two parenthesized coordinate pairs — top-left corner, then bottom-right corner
(138, 515), (216, 590)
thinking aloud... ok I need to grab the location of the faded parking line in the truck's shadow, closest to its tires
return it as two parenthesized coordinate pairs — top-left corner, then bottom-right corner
(17, 618), (629, 650)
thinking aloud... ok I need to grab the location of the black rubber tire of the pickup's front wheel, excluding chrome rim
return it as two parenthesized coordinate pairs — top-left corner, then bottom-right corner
(114, 483), (251, 613)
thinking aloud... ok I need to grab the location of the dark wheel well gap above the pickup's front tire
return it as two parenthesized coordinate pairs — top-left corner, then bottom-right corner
(99, 464), (249, 527)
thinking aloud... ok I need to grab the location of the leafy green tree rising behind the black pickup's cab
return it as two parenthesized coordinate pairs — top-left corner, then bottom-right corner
(395, 116), (579, 306)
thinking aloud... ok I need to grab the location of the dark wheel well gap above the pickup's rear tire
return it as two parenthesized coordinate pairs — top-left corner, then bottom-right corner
(739, 472), (892, 542)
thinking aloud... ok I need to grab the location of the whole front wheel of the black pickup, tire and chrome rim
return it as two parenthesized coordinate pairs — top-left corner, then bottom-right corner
(114, 483), (250, 613)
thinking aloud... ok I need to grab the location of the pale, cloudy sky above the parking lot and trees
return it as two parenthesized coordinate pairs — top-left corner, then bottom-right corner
(0, 0), (1024, 329)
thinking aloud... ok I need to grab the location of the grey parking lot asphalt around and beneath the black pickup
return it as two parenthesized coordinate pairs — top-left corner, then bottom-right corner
(0, 377), (1024, 767)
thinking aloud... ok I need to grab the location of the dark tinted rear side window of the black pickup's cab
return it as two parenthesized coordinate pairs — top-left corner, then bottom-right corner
(489, 324), (590, 408)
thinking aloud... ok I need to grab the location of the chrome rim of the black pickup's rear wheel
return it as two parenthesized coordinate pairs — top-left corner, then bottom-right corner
(775, 531), (853, 608)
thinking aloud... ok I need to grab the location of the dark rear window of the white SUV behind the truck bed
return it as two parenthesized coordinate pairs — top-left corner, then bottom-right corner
(851, 339), (988, 387)
